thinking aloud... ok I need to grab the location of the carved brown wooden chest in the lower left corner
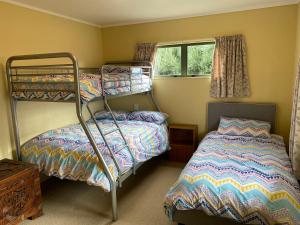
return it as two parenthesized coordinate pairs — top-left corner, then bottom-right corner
(0, 159), (42, 225)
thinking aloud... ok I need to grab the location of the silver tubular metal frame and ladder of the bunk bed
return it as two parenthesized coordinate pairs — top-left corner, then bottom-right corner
(6, 52), (160, 221)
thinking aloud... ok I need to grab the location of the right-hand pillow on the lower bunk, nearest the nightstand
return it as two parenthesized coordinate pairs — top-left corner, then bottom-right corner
(128, 111), (168, 125)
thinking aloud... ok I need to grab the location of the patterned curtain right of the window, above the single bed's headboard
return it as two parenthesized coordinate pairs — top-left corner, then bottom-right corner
(210, 35), (250, 98)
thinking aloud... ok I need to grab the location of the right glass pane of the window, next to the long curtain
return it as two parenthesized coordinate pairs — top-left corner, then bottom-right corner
(187, 43), (215, 75)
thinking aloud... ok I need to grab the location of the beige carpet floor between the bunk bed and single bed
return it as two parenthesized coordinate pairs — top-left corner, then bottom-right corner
(22, 160), (182, 225)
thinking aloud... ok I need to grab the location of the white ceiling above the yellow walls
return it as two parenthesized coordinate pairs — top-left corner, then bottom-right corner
(0, 0), (299, 27)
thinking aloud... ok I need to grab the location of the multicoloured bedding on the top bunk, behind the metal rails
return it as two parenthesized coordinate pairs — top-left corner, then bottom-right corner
(12, 66), (152, 102)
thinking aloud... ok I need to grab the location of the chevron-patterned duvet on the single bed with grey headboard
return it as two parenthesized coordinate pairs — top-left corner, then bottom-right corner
(164, 131), (300, 224)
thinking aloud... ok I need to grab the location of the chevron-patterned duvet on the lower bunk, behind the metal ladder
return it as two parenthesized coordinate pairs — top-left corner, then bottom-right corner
(21, 120), (169, 191)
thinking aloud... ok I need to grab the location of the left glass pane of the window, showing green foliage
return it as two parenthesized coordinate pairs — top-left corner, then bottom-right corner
(155, 47), (181, 76)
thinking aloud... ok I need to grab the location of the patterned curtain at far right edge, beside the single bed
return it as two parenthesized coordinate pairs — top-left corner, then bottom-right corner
(289, 60), (300, 180)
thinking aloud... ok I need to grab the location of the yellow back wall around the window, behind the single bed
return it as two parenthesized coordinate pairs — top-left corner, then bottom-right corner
(102, 5), (298, 140)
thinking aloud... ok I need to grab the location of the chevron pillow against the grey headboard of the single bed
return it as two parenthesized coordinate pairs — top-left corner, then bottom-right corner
(218, 117), (271, 138)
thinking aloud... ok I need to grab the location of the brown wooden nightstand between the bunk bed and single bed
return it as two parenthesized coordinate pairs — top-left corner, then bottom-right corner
(168, 124), (198, 163)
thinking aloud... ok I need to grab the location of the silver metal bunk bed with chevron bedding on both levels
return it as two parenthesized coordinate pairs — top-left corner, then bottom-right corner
(6, 53), (168, 221)
